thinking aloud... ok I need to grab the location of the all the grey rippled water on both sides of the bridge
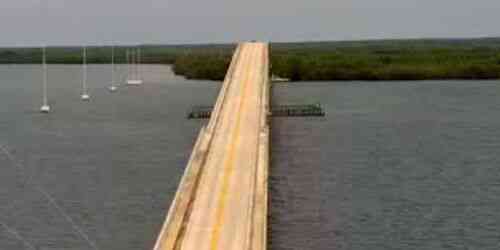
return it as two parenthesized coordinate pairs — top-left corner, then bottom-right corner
(0, 65), (500, 250)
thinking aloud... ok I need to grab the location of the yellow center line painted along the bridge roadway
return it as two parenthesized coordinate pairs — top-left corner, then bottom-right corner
(210, 46), (254, 250)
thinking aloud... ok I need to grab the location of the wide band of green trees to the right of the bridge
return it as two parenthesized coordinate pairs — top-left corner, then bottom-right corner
(271, 39), (500, 81)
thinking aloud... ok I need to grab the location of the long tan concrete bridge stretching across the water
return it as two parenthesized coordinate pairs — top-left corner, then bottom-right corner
(154, 43), (269, 250)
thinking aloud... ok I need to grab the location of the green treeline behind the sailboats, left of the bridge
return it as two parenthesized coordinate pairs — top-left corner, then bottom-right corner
(0, 44), (236, 80)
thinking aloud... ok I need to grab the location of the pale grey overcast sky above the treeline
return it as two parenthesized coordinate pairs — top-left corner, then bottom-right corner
(0, 0), (500, 46)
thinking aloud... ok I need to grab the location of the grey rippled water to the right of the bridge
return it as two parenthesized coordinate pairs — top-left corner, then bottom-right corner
(270, 81), (500, 250)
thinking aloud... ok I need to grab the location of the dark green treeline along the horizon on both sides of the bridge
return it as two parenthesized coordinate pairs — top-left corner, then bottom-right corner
(0, 38), (500, 81)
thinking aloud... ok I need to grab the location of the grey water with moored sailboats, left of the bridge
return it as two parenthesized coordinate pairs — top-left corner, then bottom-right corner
(0, 65), (219, 250)
